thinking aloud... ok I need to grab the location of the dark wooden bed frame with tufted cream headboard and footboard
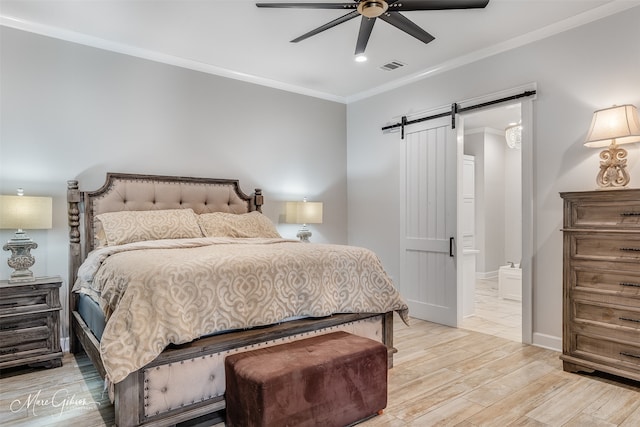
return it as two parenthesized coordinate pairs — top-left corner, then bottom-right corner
(67, 173), (395, 427)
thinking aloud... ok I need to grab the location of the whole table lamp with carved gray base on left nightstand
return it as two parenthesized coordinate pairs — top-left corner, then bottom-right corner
(0, 188), (52, 283)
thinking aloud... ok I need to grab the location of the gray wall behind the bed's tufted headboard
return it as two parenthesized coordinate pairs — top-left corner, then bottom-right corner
(0, 27), (347, 344)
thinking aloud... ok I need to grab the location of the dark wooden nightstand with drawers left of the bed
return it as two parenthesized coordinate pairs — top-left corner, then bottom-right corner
(0, 277), (62, 369)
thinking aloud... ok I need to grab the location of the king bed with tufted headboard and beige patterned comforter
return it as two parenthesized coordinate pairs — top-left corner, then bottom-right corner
(67, 173), (408, 426)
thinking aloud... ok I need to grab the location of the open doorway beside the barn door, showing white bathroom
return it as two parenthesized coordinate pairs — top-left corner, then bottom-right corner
(460, 102), (523, 342)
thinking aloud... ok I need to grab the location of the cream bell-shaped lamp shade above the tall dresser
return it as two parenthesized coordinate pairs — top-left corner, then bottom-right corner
(584, 104), (640, 147)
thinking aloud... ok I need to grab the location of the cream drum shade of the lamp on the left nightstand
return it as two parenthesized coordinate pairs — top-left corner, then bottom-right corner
(0, 196), (52, 230)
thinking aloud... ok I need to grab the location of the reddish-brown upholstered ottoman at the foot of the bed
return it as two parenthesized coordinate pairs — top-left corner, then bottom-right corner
(225, 332), (387, 427)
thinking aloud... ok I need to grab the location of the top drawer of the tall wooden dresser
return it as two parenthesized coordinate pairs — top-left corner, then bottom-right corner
(564, 190), (640, 229)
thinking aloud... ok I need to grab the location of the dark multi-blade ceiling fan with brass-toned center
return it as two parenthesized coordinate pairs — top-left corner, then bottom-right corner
(256, 0), (489, 55)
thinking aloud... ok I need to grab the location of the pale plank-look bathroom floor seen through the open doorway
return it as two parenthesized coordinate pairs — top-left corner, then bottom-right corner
(461, 279), (522, 342)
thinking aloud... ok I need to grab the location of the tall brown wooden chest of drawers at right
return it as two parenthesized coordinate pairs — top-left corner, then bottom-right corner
(560, 189), (640, 381)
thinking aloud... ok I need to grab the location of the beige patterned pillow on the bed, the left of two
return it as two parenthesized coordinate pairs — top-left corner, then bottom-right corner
(96, 209), (202, 246)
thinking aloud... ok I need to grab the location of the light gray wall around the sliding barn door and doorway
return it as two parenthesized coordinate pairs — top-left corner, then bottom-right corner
(347, 7), (640, 348)
